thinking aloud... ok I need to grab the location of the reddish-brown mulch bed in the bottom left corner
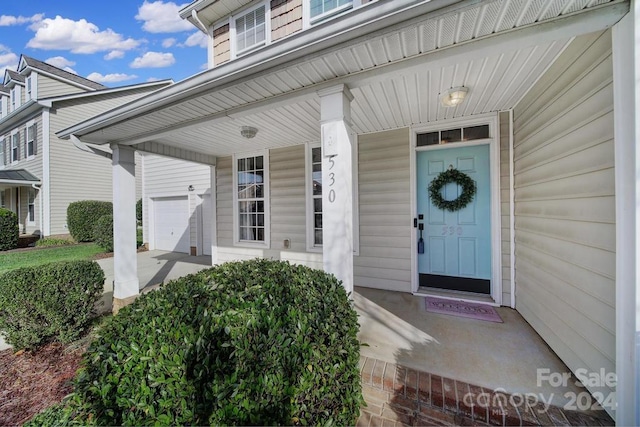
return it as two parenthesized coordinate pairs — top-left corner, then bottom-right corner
(0, 341), (88, 426)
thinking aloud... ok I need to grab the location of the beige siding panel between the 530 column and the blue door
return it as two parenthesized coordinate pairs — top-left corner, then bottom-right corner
(353, 129), (412, 292)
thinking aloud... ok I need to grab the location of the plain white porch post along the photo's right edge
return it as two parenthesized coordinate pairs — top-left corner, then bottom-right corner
(612, 4), (640, 426)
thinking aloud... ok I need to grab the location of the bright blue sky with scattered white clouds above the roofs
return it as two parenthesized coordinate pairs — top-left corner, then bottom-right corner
(0, 0), (207, 87)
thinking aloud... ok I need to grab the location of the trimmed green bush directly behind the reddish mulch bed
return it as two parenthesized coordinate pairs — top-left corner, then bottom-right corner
(0, 261), (105, 349)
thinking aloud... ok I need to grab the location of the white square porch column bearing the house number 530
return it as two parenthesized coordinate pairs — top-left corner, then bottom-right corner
(318, 85), (353, 292)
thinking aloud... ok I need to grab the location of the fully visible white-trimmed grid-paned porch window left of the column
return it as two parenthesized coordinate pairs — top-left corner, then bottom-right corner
(233, 152), (269, 246)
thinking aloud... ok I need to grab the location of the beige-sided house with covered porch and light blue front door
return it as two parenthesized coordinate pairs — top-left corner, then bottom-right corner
(59, 0), (640, 425)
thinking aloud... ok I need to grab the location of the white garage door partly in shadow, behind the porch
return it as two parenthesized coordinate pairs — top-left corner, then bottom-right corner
(153, 197), (190, 253)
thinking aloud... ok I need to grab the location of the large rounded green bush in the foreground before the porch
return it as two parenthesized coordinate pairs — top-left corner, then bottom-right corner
(66, 260), (363, 425)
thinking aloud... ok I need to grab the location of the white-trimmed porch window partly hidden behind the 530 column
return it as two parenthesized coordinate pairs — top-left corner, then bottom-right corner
(306, 141), (360, 255)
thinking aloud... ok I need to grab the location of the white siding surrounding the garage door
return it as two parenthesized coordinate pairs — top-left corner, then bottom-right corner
(143, 154), (211, 252)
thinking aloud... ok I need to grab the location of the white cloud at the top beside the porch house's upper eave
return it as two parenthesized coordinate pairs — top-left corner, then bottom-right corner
(136, 0), (193, 33)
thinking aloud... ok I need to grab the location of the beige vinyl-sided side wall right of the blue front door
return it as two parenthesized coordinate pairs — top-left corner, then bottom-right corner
(514, 31), (615, 402)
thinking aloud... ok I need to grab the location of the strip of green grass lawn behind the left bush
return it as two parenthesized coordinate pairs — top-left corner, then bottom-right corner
(0, 243), (104, 273)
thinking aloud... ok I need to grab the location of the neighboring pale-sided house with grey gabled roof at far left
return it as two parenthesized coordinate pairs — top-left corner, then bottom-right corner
(0, 55), (172, 236)
